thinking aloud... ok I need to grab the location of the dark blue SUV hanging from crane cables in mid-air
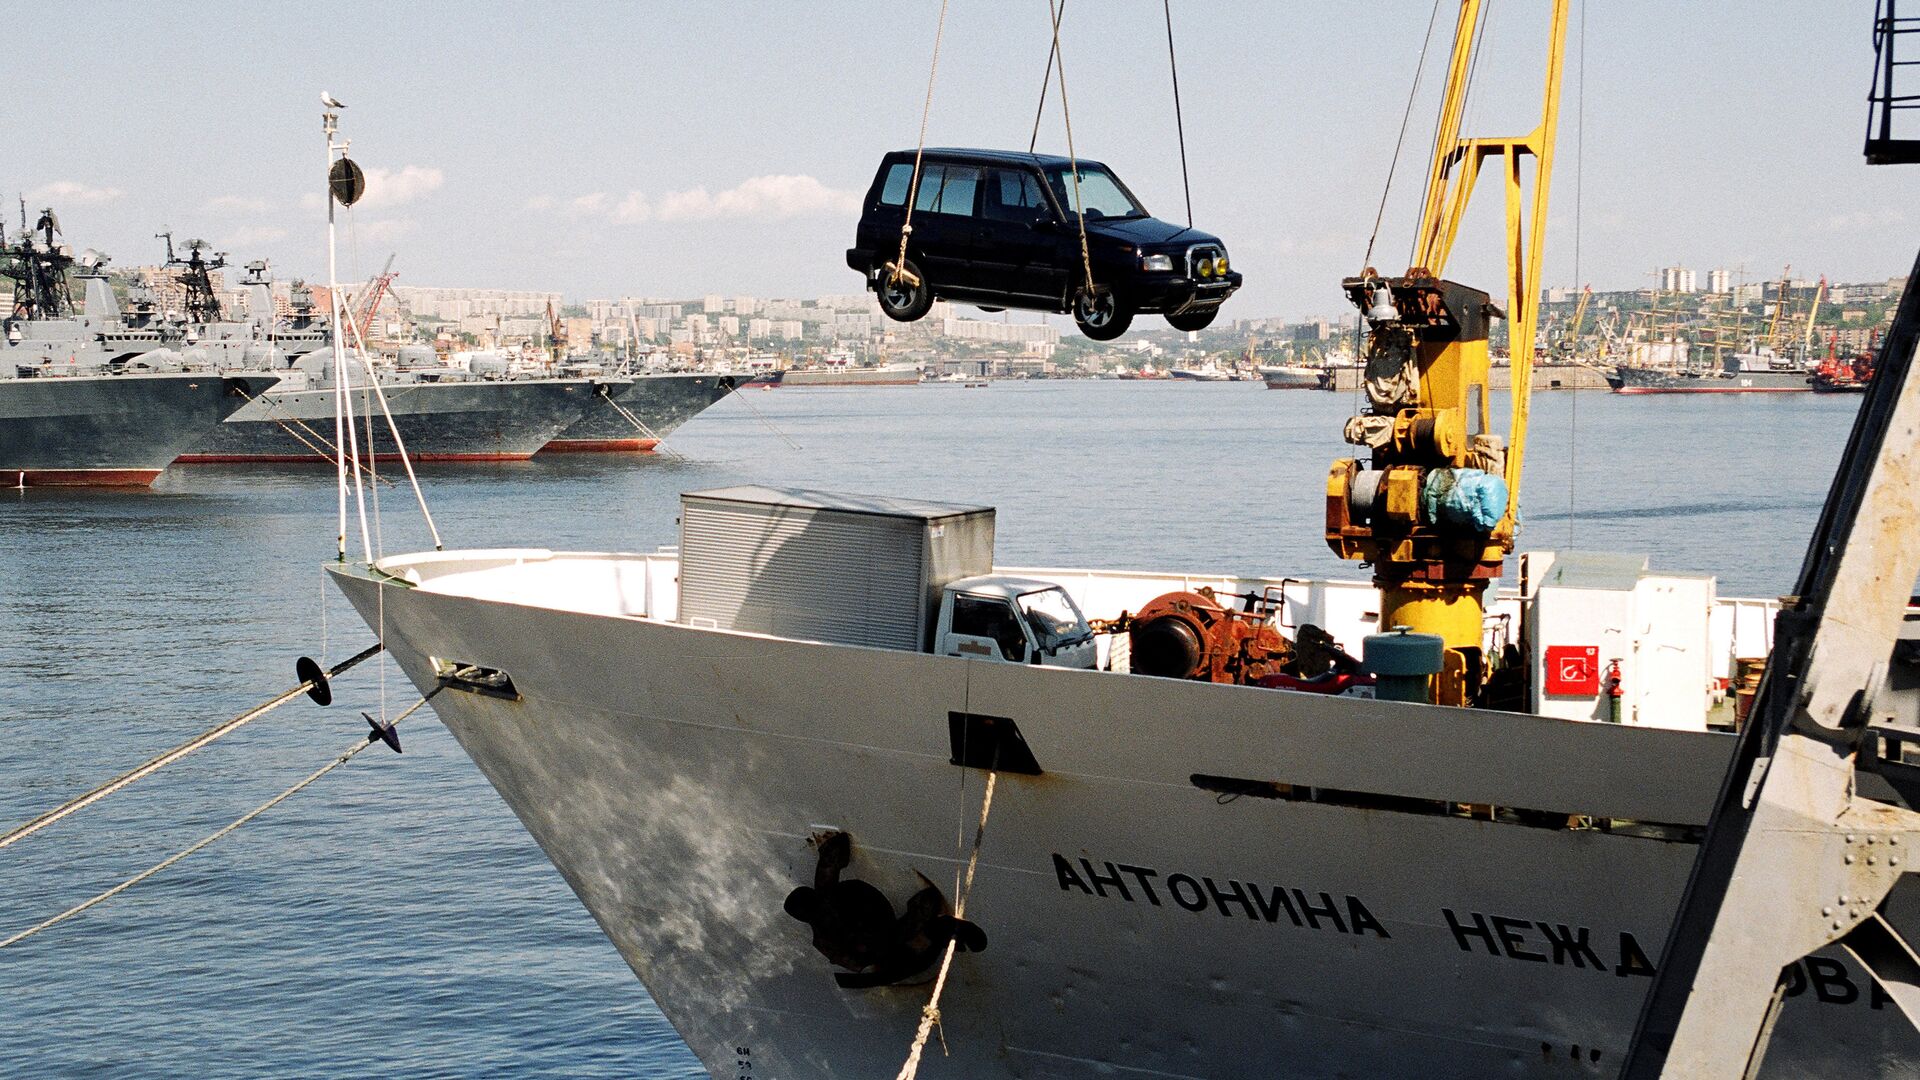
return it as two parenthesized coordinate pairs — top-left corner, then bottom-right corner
(847, 150), (1240, 342)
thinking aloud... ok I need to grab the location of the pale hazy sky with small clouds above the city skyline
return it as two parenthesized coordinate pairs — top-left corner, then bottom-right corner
(0, 0), (1920, 317)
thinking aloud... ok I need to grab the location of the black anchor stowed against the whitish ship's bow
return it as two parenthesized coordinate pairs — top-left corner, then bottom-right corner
(783, 832), (987, 990)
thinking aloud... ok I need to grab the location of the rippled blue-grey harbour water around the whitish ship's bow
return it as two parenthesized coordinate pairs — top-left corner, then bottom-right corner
(0, 382), (1859, 1078)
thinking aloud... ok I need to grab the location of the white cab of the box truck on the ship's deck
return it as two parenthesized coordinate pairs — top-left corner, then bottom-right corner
(933, 575), (1098, 669)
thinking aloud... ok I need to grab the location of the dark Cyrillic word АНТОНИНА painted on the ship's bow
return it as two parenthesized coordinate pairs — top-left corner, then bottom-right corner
(1054, 853), (1390, 933)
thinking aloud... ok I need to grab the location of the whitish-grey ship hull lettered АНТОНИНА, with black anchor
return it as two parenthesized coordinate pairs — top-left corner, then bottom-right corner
(334, 552), (1920, 1080)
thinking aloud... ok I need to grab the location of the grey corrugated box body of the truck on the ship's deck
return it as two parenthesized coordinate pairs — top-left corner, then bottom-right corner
(680, 486), (993, 651)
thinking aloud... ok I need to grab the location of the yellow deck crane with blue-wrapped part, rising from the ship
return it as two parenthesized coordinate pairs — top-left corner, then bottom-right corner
(1327, 0), (1567, 705)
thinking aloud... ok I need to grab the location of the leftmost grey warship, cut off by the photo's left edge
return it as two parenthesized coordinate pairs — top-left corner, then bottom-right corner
(0, 209), (275, 488)
